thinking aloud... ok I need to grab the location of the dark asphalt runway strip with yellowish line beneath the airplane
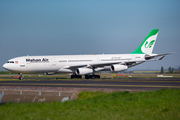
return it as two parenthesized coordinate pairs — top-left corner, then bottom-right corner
(0, 78), (180, 90)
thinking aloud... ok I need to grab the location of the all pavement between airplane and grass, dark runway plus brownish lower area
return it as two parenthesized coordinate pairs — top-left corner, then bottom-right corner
(0, 77), (180, 104)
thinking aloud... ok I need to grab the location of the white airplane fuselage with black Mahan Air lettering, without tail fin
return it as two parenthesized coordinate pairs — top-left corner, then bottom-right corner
(3, 54), (145, 73)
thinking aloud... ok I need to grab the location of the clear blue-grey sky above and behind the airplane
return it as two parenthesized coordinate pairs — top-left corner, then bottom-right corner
(0, 0), (180, 71)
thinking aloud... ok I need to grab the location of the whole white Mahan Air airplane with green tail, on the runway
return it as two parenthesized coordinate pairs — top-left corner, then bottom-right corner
(3, 29), (173, 80)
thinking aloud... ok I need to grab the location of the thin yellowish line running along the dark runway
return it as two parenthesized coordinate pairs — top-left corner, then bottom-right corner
(0, 83), (180, 88)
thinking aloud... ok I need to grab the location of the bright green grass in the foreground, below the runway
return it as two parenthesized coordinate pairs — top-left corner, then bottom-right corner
(0, 89), (180, 120)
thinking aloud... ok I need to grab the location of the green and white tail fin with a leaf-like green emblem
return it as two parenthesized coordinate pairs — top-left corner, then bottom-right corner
(131, 29), (159, 54)
